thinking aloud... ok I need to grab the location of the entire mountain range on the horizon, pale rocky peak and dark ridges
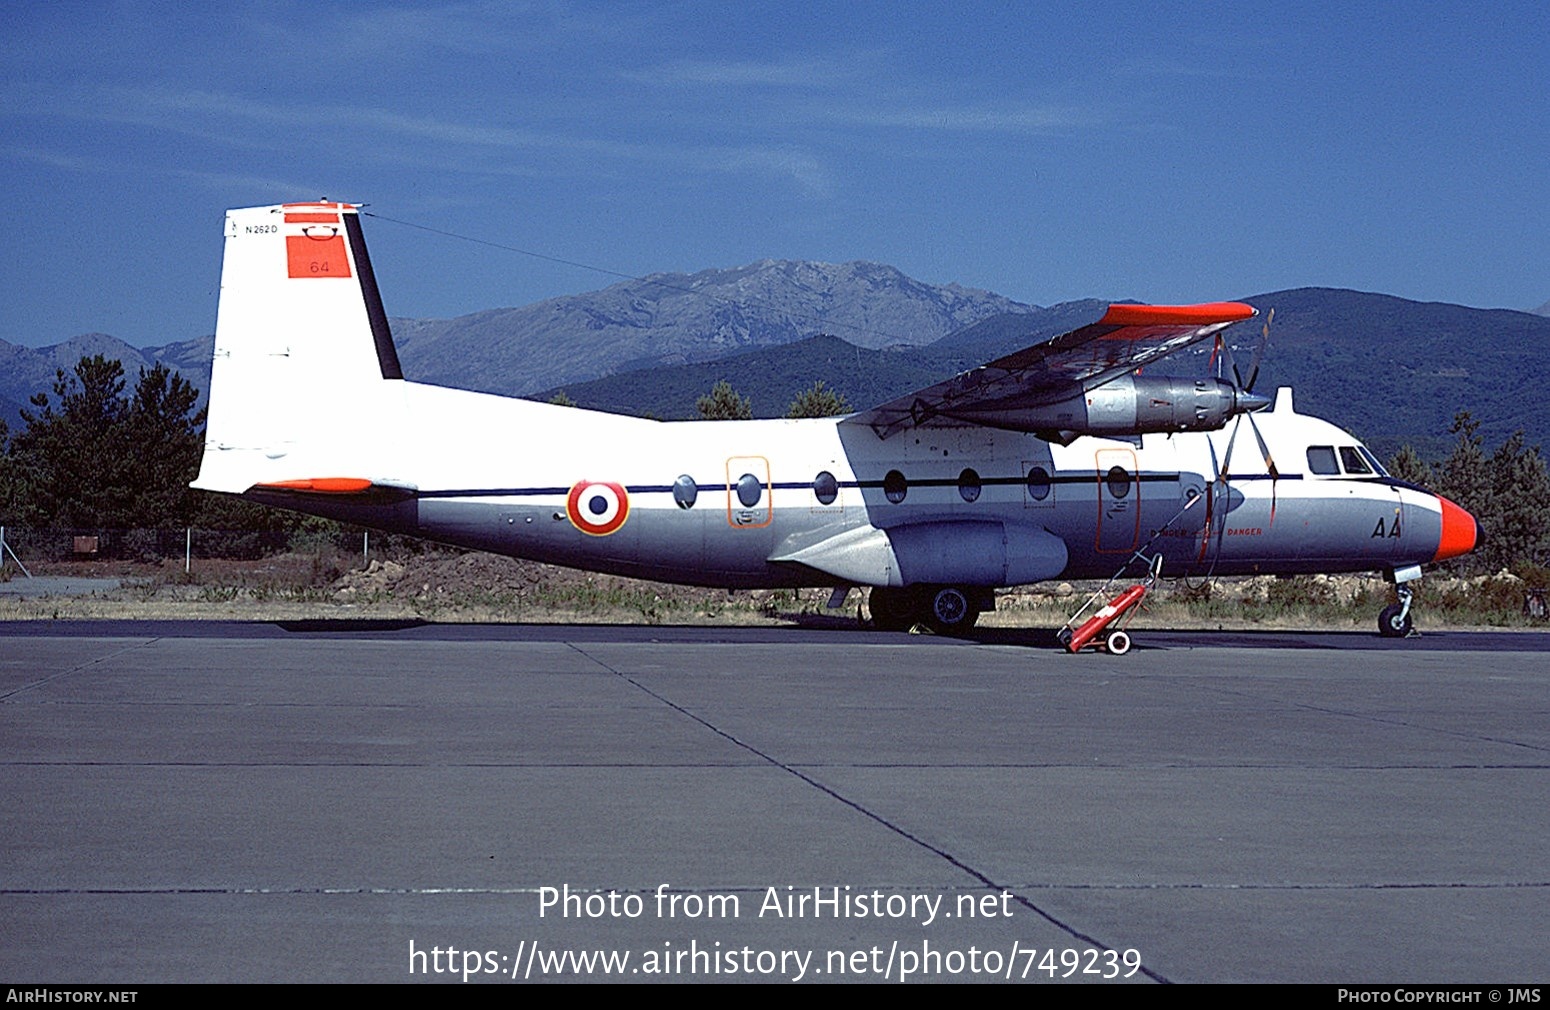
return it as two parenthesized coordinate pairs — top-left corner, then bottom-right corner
(0, 260), (1550, 457)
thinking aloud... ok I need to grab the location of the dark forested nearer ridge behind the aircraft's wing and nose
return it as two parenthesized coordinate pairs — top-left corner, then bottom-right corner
(550, 288), (1550, 459)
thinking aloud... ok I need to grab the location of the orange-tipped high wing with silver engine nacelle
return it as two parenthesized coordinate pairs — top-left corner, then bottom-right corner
(845, 302), (1268, 440)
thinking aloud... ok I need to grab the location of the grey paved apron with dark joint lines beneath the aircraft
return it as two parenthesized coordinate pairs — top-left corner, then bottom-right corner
(0, 621), (1550, 985)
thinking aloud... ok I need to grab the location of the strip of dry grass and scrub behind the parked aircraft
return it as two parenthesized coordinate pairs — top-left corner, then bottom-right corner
(0, 547), (1544, 630)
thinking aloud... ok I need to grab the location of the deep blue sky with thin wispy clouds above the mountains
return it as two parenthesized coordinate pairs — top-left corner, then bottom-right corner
(0, 0), (1550, 345)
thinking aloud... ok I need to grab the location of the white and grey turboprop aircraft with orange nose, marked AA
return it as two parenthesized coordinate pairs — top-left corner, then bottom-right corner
(194, 203), (1479, 635)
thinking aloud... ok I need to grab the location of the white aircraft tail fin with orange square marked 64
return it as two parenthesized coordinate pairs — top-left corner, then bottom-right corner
(194, 203), (403, 493)
